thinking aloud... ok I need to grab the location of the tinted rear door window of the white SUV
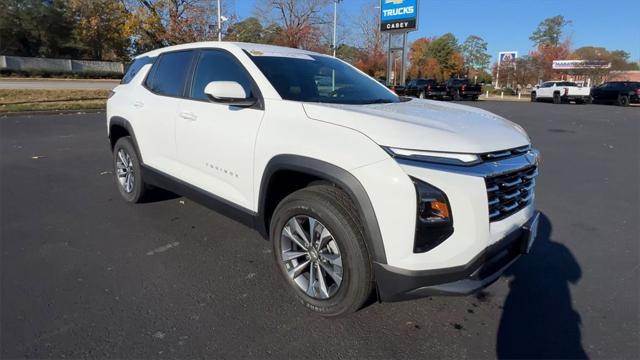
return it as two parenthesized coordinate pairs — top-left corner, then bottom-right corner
(145, 51), (193, 97)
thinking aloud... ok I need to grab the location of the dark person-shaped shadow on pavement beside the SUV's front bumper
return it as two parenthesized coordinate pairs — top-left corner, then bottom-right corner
(496, 214), (587, 359)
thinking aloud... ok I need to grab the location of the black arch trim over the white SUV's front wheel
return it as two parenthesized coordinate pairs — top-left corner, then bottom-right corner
(256, 154), (387, 264)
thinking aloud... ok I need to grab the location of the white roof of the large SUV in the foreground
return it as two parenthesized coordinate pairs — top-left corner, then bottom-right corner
(136, 41), (326, 58)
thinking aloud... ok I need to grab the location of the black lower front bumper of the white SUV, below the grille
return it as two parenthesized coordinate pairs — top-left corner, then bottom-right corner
(374, 213), (539, 301)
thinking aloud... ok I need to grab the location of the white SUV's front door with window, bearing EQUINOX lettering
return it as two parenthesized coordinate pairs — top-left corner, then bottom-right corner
(176, 49), (264, 209)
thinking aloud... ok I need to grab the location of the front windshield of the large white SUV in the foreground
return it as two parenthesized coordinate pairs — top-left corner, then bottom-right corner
(249, 53), (400, 104)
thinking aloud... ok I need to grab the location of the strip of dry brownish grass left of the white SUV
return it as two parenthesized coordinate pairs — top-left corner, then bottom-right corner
(0, 89), (109, 113)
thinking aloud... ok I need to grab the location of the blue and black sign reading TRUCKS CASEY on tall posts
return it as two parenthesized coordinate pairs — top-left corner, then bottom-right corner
(380, 0), (418, 31)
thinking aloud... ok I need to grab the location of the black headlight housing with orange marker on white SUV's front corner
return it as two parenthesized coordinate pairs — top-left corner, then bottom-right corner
(411, 178), (453, 253)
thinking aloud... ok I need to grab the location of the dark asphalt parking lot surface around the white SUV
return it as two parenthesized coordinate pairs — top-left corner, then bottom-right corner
(0, 102), (640, 359)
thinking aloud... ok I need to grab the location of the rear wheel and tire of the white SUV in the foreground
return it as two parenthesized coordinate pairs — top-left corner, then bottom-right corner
(113, 136), (147, 203)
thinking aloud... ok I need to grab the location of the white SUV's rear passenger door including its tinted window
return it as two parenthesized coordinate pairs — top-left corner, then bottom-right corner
(132, 50), (194, 176)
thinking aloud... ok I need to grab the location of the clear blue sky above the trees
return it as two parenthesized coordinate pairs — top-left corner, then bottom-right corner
(223, 0), (640, 61)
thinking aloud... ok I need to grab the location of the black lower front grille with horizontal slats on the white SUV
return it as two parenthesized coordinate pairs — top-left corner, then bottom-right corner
(485, 166), (538, 221)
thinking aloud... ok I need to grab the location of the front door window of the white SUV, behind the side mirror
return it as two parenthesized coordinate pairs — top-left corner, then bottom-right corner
(191, 50), (252, 100)
